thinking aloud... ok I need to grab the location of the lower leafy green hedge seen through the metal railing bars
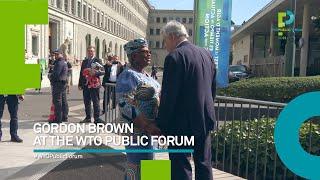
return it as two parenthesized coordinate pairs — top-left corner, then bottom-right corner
(212, 118), (320, 179)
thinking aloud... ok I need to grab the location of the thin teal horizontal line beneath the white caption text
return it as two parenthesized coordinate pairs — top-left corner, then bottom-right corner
(33, 149), (193, 153)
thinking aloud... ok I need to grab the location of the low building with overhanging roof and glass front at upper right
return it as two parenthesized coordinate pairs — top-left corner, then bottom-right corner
(232, 0), (320, 76)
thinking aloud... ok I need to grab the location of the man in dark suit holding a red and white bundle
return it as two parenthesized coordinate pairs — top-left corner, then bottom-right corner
(78, 46), (105, 123)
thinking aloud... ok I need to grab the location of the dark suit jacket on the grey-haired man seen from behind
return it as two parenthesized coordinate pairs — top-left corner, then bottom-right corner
(157, 41), (216, 137)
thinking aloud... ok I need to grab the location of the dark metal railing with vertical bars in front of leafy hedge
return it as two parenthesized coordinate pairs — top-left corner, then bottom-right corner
(212, 96), (320, 180)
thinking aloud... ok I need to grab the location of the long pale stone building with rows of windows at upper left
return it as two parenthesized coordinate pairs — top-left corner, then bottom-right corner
(25, 0), (151, 66)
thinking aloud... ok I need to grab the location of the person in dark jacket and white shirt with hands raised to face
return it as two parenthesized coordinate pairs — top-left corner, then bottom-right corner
(102, 54), (123, 113)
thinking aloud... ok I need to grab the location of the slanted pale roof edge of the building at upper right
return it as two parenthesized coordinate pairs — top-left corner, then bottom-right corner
(231, 0), (285, 39)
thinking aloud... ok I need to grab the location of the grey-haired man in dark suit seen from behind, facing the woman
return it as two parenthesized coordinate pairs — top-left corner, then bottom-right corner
(157, 21), (216, 180)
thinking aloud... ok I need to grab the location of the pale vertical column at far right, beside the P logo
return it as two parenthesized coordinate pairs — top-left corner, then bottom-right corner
(300, 2), (310, 76)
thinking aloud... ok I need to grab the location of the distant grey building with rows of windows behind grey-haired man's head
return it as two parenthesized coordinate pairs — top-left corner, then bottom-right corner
(147, 9), (194, 67)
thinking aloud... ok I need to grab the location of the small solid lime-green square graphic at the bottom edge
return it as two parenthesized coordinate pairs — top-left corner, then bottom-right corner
(141, 160), (171, 180)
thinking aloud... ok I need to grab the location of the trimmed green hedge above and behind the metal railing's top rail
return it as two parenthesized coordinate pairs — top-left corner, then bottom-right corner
(218, 76), (320, 103)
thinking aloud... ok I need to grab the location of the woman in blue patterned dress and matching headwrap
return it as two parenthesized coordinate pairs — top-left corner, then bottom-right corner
(116, 39), (161, 179)
